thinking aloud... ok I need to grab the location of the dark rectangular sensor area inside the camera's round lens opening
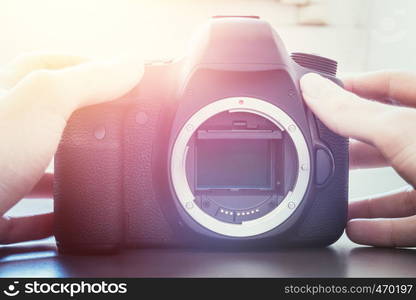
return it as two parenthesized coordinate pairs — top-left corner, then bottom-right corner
(196, 139), (276, 190)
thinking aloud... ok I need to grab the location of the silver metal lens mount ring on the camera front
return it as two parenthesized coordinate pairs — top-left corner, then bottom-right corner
(170, 97), (311, 237)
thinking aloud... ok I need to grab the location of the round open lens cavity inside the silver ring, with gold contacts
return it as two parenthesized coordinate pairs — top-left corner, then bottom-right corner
(187, 112), (297, 224)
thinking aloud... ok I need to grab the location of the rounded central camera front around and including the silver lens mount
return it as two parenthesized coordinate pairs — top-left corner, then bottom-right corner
(164, 69), (324, 245)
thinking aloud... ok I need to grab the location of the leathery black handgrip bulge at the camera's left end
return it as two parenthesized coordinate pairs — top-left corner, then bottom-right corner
(54, 103), (123, 253)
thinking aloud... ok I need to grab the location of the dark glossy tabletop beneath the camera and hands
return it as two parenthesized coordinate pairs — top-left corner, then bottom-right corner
(0, 236), (416, 277)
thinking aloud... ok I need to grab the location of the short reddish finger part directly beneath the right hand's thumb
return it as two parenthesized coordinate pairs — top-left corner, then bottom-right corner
(349, 141), (388, 169)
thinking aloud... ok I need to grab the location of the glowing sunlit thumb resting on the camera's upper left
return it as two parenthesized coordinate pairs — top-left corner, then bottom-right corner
(8, 57), (144, 119)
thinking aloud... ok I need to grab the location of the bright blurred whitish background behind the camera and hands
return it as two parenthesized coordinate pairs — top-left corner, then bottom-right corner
(0, 0), (416, 214)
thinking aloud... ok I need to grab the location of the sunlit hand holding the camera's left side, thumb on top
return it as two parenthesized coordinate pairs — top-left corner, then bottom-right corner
(0, 54), (143, 244)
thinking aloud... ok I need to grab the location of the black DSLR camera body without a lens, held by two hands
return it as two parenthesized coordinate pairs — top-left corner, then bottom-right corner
(54, 17), (348, 253)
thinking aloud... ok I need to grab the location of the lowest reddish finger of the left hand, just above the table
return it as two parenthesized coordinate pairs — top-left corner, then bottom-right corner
(0, 213), (53, 244)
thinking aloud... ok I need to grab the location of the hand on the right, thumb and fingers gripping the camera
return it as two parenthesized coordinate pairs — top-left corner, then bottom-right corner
(300, 72), (416, 247)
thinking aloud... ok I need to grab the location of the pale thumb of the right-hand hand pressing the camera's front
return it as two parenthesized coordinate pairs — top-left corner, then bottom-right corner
(300, 73), (416, 186)
